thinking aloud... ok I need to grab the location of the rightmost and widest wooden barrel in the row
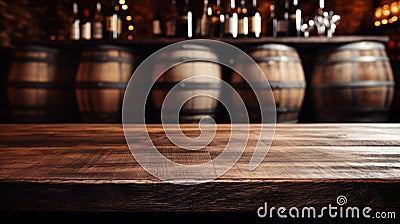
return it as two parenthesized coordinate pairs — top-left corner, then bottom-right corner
(311, 41), (394, 122)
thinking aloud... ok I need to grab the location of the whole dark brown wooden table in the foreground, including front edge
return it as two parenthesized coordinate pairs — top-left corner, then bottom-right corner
(0, 124), (400, 223)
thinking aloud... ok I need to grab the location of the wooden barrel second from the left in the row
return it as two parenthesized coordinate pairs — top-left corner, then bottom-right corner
(75, 45), (135, 123)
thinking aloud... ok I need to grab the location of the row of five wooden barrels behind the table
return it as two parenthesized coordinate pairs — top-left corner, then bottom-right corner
(2, 41), (395, 122)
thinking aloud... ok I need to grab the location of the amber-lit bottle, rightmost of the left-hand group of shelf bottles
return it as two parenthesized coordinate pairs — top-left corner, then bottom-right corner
(105, 0), (122, 40)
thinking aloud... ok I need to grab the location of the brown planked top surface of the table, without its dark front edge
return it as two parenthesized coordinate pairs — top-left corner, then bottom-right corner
(0, 124), (400, 180)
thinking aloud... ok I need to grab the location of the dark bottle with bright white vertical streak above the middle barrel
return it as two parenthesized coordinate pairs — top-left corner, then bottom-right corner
(176, 0), (193, 38)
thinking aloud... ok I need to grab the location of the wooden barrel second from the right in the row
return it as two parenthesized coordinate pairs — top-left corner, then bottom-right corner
(231, 44), (306, 123)
